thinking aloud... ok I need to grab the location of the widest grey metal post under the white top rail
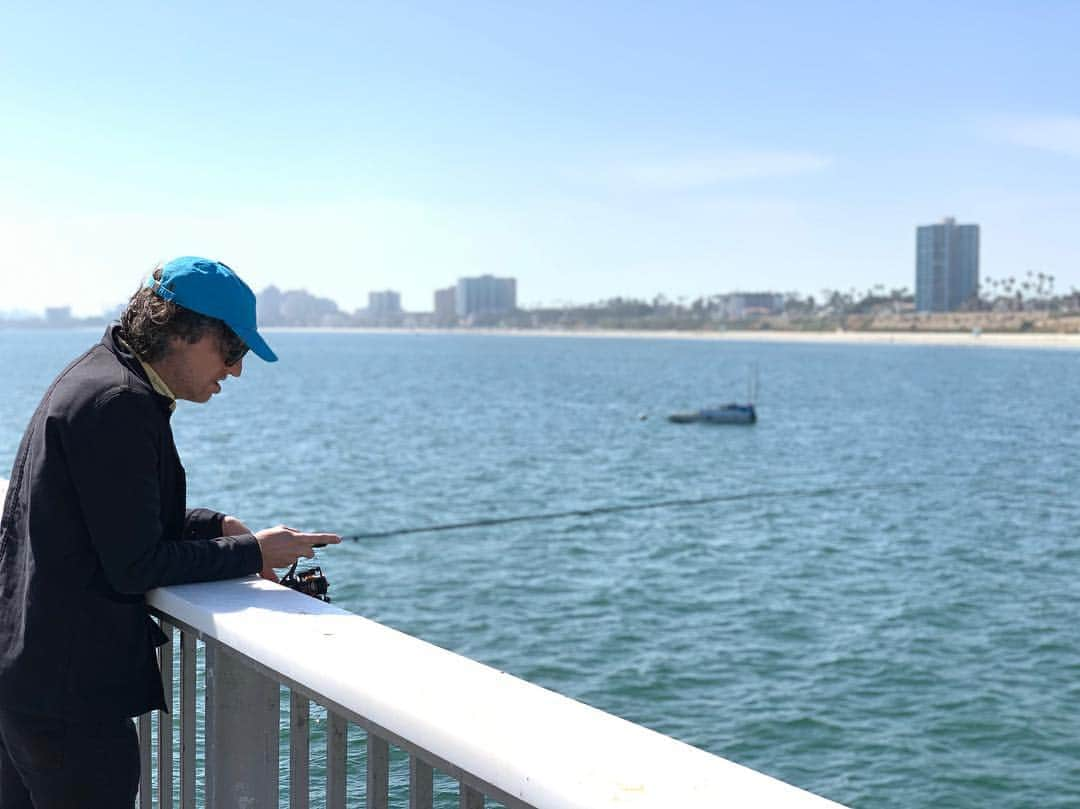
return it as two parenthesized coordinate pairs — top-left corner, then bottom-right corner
(206, 643), (279, 809)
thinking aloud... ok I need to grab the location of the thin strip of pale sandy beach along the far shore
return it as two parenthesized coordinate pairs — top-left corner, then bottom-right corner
(261, 326), (1080, 350)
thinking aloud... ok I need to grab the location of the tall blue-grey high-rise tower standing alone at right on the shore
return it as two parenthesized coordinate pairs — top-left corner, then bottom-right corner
(915, 217), (978, 312)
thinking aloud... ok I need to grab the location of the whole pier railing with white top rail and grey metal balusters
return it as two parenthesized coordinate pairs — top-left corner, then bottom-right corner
(0, 480), (839, 809)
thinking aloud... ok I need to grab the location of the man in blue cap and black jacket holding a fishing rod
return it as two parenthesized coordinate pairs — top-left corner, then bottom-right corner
(0, 256), (340, 809)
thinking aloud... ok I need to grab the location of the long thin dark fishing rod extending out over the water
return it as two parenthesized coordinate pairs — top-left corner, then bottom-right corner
(341, 481), (923, 541)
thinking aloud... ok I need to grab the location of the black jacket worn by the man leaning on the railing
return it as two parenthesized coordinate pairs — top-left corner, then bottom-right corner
(0, 324), (261, 718)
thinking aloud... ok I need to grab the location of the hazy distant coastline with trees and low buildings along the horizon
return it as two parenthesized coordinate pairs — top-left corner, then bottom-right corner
(8, 286), (1080, 336)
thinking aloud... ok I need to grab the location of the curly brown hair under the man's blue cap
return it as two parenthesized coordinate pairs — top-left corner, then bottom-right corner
(120, 265), (244, 362)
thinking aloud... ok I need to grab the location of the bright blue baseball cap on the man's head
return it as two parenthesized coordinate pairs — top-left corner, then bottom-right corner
(146, 256), (278, 362)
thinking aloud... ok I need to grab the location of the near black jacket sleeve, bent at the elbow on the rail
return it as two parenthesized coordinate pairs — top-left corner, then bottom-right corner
(64, 388), (262, 593)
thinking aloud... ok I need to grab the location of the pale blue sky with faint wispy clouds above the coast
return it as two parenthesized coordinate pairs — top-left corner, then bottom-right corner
(0, 0), (1080, 313)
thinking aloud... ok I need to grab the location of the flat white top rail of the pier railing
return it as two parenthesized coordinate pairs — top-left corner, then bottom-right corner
(147, 577), (839, 809)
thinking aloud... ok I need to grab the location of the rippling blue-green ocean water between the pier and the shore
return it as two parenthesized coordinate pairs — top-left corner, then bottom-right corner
(0, 331), (1080, 808)
